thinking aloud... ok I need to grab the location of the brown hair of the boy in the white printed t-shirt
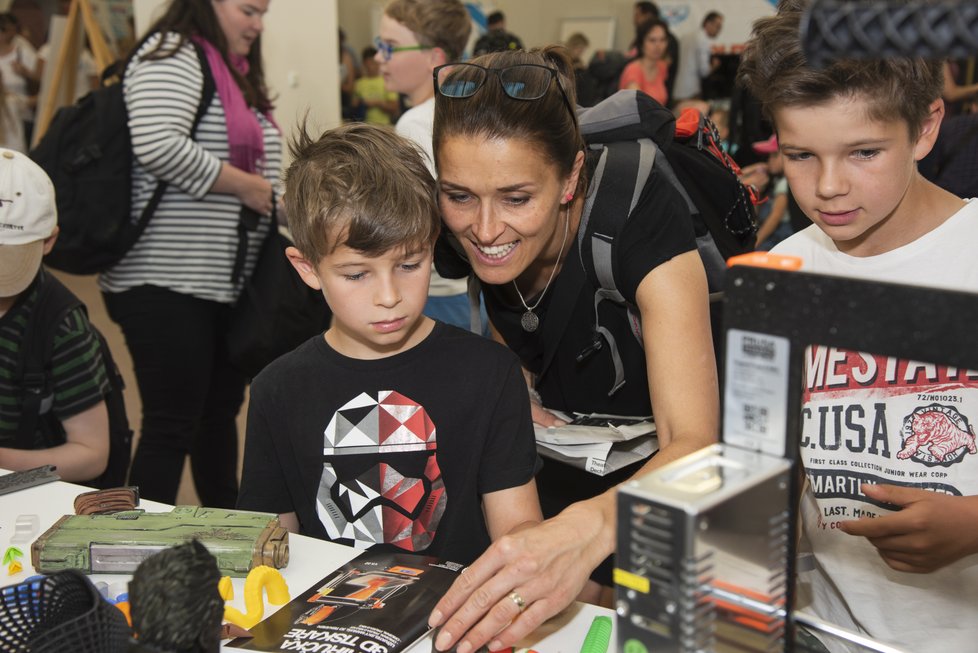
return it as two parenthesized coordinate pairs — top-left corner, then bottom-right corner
(737, 0), (944, 140)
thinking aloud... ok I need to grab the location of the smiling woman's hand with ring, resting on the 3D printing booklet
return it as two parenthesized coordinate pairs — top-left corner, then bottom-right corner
(428, 493), (615, 653)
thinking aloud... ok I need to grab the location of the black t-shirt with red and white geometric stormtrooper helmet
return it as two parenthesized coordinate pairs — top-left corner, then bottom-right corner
(238, 323), (538, 564)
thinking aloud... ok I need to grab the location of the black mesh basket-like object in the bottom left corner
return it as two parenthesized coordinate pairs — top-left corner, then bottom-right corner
(0, 569), (130, 653)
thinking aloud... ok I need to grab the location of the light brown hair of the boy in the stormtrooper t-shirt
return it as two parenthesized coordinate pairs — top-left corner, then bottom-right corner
(283, 123), (441, 263)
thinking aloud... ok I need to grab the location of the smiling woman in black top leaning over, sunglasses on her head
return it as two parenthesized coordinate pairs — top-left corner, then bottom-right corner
(431, 48), (718, 650)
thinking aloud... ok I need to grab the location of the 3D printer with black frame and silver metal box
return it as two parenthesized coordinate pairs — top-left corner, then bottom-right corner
(615, 266), (978, 653)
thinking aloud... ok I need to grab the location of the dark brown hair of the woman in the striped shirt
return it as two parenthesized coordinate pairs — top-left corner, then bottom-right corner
(134, 0), (272, 111)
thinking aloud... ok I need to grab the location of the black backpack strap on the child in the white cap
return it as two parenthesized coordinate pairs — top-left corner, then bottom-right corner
(17, 271), (84, 449)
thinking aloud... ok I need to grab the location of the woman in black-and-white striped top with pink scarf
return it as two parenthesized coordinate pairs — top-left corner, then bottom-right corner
(99, 0), (282, 507)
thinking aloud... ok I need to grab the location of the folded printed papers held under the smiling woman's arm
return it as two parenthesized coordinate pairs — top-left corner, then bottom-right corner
(534, 410), (659, 476)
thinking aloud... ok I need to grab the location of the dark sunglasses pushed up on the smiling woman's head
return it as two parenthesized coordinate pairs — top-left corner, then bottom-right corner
(433, 63), (576, 116)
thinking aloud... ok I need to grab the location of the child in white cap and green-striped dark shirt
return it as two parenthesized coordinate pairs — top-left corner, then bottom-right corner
(0, 149), (110, 481)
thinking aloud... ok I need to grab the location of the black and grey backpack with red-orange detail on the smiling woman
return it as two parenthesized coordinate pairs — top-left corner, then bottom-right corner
(577, 90), (757, 394)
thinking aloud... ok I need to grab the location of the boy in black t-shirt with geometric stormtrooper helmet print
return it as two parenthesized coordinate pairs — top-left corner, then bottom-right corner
(238, 124), (541, 563)
